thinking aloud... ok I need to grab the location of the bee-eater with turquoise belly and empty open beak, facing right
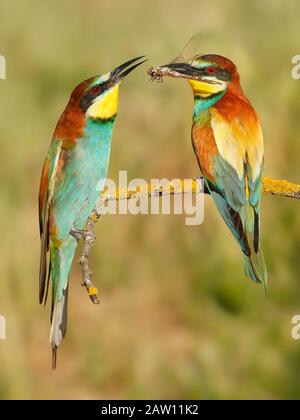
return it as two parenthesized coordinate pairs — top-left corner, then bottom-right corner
(39, 57), (143, 368)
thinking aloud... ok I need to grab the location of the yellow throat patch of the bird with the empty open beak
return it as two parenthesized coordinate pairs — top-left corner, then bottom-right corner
(87, 83), (119, 120)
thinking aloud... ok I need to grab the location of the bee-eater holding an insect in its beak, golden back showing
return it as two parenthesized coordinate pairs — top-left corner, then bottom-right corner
(148, 54), (267, 288)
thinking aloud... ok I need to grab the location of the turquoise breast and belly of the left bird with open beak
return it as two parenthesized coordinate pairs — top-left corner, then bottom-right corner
(53, 119), (114, 239)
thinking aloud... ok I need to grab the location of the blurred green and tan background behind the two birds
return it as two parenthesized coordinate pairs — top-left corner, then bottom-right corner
(0, 0), (300, 399)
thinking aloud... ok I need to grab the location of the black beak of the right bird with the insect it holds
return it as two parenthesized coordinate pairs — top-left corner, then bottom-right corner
(148, 63), (200, 80)
